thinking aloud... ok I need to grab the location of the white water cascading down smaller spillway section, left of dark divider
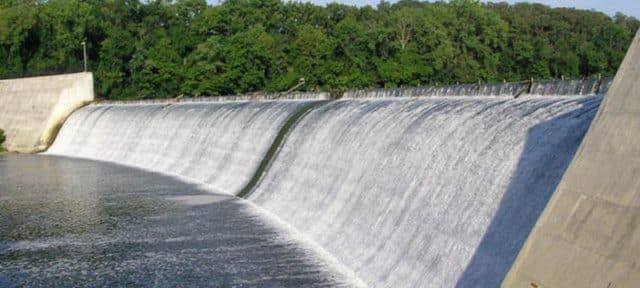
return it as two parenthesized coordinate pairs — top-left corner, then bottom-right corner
(47, 101), (310, 194)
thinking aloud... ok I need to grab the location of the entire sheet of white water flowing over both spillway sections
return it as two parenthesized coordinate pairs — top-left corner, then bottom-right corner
(48, 94), (602, 287)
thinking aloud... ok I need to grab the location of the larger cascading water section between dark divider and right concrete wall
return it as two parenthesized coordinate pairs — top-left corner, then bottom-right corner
(249, 96), (602, 287)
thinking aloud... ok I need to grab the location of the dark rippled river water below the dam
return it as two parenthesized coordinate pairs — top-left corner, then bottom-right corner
(0, 155), (358, 287)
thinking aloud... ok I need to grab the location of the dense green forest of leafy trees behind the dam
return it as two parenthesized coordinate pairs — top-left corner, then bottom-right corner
(0, 0), (640, 99)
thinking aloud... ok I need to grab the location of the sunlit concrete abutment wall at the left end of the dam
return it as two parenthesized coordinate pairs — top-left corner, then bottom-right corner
(0, 73), (94, 153)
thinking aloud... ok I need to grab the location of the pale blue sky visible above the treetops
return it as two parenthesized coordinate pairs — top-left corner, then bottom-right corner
(207, 0), (640, 19)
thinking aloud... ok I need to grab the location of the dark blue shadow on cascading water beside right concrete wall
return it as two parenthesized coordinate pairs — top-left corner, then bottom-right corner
(456, 97), (602, 287)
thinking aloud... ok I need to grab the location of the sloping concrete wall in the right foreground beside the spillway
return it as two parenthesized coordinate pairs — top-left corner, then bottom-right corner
(502, 32), (640, 288)
